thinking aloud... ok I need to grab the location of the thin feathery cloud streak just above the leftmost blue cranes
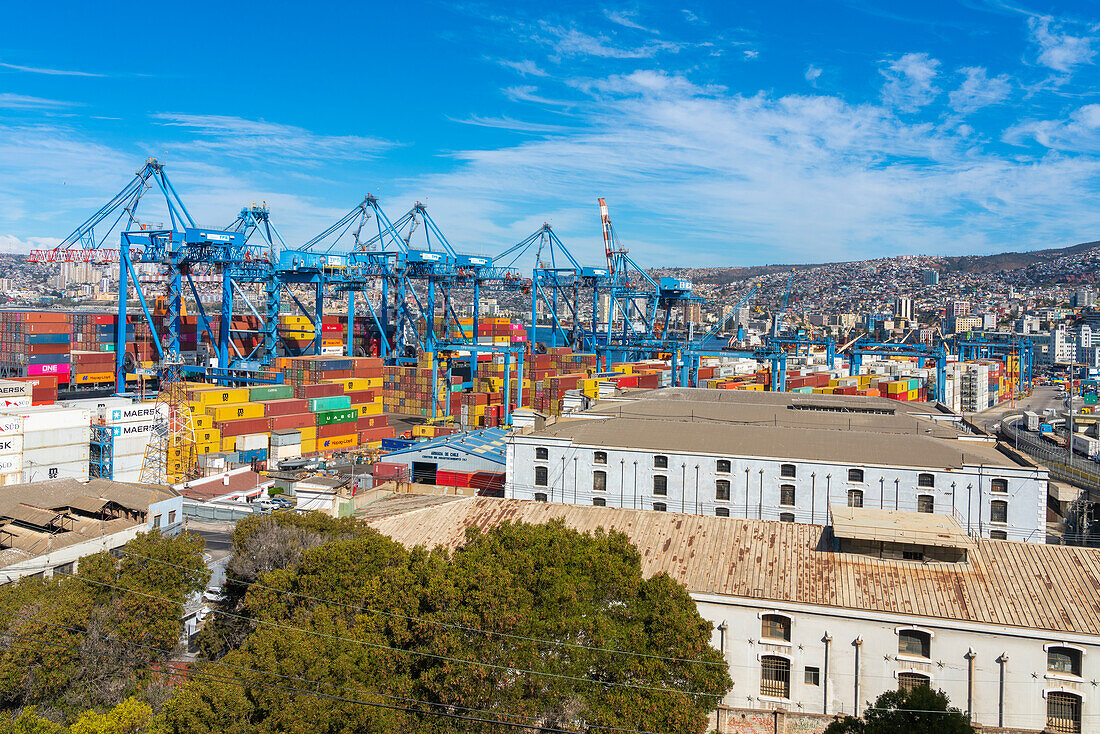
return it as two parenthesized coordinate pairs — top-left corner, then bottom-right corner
(151, 112), (394, 165)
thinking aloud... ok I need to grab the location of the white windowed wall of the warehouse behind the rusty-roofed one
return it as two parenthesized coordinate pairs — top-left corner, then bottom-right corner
(505, 433), (1047, 543)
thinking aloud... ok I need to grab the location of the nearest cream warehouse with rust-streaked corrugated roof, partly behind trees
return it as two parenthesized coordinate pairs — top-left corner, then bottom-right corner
(372, 497), (1100, 734)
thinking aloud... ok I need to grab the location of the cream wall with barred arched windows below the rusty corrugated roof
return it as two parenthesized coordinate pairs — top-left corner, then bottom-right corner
(693, 594), (1100, 731)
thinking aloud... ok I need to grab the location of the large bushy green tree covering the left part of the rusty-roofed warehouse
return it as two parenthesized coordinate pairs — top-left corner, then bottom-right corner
(164, 523), (733, 734)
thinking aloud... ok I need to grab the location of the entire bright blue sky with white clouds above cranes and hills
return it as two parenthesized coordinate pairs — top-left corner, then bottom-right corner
(0, 0), (1100, 265)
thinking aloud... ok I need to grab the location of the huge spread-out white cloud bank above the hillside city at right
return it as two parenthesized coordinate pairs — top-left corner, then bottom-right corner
(404, 70), (1100, 265)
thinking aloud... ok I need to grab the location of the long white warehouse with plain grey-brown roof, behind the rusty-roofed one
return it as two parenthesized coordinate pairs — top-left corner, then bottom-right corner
(505, 388), (1048, 543)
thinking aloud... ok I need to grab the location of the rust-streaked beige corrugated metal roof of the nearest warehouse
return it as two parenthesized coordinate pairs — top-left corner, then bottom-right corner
(372, 497), (1100, 635)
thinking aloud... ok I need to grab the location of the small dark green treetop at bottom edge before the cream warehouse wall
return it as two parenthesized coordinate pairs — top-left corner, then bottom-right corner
(825, 686), (975, 734)
